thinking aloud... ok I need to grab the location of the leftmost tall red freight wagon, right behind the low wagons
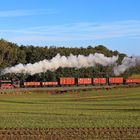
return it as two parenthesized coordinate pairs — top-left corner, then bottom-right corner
(59, 77), (75, 85)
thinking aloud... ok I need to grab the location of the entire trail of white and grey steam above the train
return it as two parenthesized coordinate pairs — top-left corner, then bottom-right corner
(3, 53), (140, 76)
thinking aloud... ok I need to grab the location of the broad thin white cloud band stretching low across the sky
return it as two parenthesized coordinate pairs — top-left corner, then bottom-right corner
(0, 20), (140, 44)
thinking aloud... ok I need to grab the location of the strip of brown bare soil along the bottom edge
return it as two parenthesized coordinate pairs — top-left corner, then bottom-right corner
(0, 128), (140, 140)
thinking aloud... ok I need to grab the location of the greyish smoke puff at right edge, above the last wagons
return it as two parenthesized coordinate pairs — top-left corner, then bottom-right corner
(114, 57), (140, 76)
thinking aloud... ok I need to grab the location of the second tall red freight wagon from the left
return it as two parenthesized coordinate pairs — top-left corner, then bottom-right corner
(76, 78), (92, 85)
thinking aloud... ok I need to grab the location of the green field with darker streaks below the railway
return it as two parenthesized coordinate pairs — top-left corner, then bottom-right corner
(0, 87), (140, 128)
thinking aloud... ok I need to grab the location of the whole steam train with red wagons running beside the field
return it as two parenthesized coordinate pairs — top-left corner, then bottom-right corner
(0, 77), (140, 89)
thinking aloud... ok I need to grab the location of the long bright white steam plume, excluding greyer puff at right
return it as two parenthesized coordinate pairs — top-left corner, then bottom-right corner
(3, 53), (118, 75)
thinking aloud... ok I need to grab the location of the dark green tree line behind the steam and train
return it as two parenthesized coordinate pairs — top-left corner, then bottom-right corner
(0, 39), (140, 81)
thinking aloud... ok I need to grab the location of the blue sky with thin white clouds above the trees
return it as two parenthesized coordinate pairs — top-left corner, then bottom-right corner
(0, 0), (140, 55)
